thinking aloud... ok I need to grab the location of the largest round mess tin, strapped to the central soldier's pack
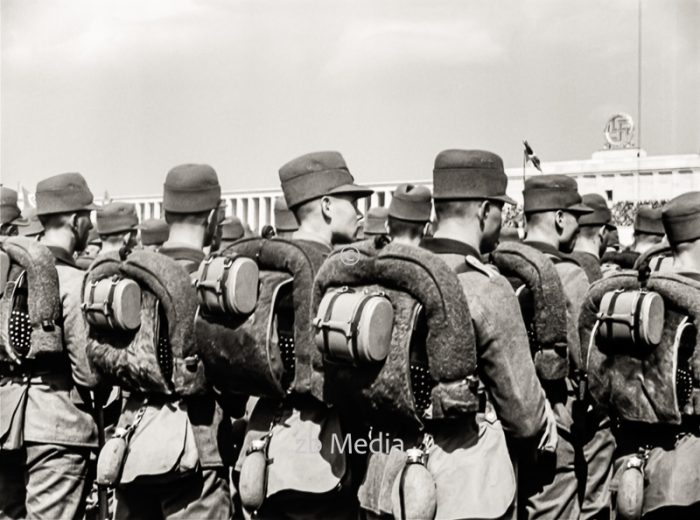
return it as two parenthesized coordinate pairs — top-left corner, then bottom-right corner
(313, 287), (394, 364)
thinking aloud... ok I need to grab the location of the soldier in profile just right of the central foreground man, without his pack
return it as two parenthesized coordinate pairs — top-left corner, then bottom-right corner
(523, 175), (615, 518)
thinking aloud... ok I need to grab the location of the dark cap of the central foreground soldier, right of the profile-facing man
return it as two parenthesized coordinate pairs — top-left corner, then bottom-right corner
(433, 150), (515, 204)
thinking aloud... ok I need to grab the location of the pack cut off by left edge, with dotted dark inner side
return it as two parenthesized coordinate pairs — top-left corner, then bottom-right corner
(0, 237), (63, 363)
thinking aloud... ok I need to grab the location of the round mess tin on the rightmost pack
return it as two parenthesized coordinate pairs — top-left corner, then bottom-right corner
(597, 290), (665, 347)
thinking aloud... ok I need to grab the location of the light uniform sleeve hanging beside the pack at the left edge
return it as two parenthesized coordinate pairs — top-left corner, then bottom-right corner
(57, 266), (98, 388)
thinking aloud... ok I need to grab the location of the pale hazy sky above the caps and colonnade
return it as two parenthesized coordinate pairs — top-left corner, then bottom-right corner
(0, 0), (700, 196)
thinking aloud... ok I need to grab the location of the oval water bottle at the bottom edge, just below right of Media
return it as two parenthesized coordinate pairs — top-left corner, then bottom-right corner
(391, 448), (437, 520)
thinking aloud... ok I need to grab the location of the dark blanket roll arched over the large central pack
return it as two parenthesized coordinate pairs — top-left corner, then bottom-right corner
(313, 241), (478, 422)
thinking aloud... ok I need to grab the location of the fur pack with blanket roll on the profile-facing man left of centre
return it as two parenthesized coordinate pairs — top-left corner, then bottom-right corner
(196, 237), (325, 399)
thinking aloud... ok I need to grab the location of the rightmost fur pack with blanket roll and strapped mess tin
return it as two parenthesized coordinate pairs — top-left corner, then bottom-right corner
(579, 271), (700, 424)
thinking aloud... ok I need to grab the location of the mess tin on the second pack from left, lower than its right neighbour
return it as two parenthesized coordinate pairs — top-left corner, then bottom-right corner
(82, 276), (141, 331)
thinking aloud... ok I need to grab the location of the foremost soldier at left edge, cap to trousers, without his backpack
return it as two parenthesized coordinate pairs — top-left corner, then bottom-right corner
(0, 173), (98, 519)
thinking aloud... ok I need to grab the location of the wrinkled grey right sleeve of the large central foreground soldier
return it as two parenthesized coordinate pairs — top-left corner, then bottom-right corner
(460, 274), (545, 439)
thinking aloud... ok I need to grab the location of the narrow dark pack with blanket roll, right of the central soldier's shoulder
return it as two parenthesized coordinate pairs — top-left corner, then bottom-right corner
(491, 242), (570, 381)
